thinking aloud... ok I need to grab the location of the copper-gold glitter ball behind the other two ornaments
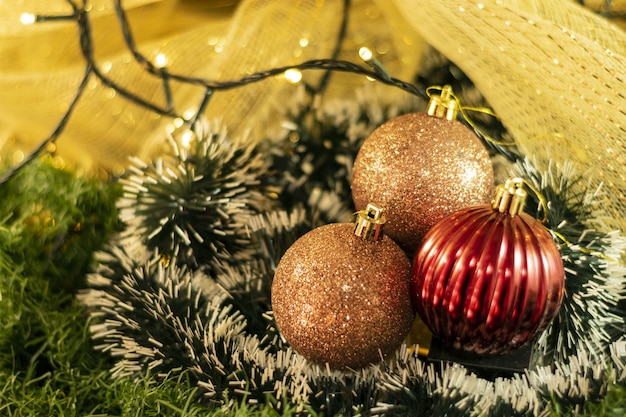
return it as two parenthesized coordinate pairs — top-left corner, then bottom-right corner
(351, 86), (494, 250)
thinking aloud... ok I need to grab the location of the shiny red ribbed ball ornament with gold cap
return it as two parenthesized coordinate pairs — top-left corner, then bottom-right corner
(411, 179), (565, 355)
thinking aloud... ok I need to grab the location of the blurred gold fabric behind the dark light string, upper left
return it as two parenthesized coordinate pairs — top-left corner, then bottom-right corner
(0, 0), (420, 169)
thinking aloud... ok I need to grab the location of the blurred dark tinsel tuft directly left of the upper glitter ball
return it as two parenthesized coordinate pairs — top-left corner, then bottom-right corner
(269, 85), (416, 225)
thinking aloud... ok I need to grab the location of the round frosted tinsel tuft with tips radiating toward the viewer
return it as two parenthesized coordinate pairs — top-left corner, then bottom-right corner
(119, 121), (273, 267)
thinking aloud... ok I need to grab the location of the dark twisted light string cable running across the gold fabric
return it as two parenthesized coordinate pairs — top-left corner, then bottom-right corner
(0, 0), (428, 185)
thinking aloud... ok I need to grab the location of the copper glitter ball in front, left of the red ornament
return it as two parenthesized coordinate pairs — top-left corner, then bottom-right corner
(272, 204), (414, 369)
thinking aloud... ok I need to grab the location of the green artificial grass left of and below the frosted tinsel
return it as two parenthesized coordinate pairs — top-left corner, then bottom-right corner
(0, 161), (288, 417)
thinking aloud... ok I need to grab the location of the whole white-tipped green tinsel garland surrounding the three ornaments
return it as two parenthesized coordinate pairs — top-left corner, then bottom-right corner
(81, 88), (626, 416)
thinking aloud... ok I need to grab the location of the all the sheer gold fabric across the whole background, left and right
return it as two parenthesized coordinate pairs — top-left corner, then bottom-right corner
(0, 0), (626, 234)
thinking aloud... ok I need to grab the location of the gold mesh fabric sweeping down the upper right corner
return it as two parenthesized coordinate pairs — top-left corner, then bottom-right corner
(396, 0), (626, 234)
